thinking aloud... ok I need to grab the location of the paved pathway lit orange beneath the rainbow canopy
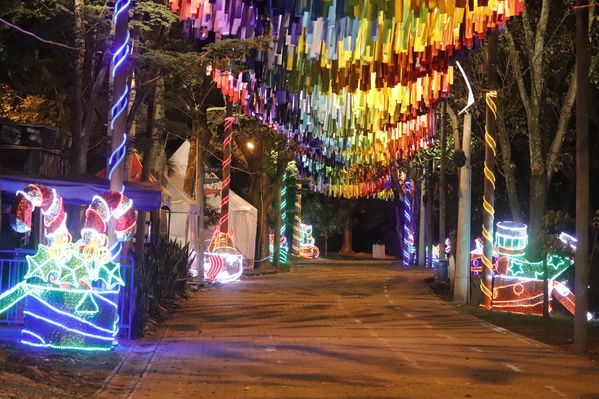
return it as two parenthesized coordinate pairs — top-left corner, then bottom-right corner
(98, 265), (599, 399)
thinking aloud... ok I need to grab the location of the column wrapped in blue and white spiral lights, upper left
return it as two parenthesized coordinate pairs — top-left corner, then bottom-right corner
(106, 0), (131, 191)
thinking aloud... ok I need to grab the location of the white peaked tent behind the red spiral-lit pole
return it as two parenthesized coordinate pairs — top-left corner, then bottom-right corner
(167, 140), (258, 268)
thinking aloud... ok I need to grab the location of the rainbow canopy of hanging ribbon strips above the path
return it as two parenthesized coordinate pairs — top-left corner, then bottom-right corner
(171, 0), (523, 197)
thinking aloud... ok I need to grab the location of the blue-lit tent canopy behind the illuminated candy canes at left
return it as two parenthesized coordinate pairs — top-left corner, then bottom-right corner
(0, 175), (162, 211)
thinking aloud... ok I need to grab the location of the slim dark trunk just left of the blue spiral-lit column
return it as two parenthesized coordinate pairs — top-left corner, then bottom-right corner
(71, 0), (87, 173)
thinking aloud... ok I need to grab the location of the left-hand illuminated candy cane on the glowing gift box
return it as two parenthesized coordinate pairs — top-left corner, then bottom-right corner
(12, 184), (67, 237)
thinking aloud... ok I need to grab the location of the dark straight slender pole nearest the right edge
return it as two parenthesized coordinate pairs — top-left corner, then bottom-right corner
(574, 1), (590, 353)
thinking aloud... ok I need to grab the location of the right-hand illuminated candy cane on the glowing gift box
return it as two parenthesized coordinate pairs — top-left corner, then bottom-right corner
(81, 191), (136, 243)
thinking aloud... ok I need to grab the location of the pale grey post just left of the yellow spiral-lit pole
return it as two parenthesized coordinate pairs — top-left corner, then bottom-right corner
(453, 113), (472, 303)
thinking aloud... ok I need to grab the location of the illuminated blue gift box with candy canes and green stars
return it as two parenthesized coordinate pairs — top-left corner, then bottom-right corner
(0, 184), (135, 350)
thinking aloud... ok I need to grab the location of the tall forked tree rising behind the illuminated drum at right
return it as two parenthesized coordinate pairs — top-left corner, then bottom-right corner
(500, 0), (588, 258)
